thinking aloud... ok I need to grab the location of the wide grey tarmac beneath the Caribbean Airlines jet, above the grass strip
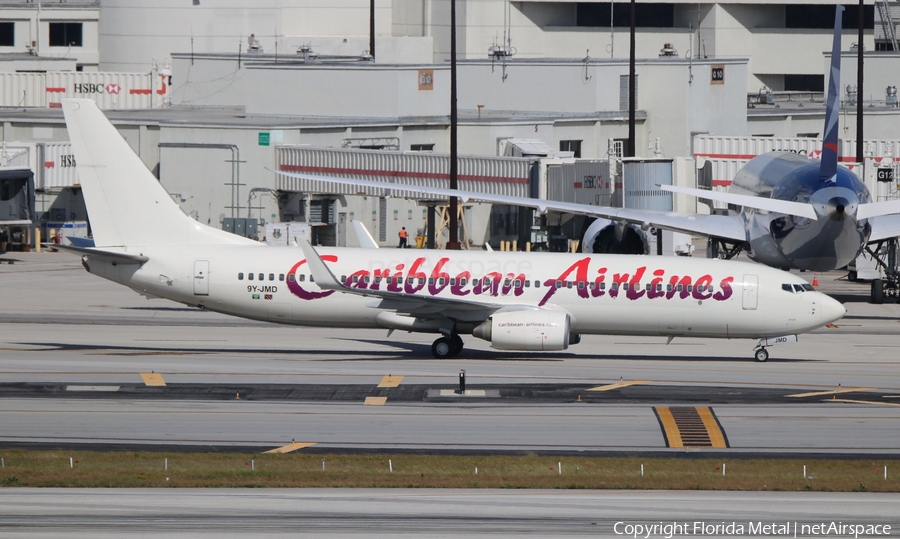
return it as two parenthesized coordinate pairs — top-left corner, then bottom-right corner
(0, 253), (900, 456)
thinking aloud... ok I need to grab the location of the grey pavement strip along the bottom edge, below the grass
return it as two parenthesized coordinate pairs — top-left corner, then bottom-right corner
(0, 489), (900, 539)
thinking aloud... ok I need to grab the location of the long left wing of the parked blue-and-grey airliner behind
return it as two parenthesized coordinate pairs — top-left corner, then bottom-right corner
(268, 169), (747, 242)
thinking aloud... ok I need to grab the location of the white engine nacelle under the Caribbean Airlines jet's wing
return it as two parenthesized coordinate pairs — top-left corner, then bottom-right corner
(472, 310), (580, 351)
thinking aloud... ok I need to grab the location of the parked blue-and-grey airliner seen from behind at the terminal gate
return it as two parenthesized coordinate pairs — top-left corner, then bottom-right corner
(276, 6), (900, 303)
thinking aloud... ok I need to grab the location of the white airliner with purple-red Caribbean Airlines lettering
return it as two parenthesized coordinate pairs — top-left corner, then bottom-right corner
(63, 99), (845, 361)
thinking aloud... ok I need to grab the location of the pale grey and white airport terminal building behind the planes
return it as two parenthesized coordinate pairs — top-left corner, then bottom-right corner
(0, 0), (900, 253)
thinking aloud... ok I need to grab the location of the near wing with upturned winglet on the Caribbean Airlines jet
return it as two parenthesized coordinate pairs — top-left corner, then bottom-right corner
(300, 240), (535, 321)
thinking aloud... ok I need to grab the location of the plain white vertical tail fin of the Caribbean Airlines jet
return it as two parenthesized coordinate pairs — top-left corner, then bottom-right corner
(62, 99), (257, 247)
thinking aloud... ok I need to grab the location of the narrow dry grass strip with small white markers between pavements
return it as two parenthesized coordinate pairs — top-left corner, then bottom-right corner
(0, 450), (900, 492)
